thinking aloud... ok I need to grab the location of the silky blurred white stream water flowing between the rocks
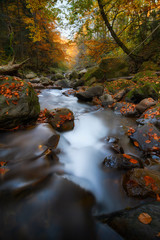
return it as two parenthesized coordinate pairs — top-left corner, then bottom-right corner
(0, 90), (142, 240)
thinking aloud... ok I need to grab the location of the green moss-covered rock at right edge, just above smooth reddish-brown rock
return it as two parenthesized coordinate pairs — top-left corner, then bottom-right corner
(125, 83), (158, 104)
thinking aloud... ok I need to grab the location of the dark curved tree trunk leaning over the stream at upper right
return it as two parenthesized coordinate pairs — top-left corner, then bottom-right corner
(98, 0), (143, 63)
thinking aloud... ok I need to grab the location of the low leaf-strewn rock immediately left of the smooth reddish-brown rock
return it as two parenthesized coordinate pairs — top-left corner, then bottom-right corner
(114, 102), (138, 117)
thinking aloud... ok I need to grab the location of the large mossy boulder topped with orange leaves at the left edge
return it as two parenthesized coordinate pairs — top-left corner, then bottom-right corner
(0, 76), (40, 129)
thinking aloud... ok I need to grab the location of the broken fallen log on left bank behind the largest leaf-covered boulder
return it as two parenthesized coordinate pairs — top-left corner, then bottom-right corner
(0, 58), (29, 75)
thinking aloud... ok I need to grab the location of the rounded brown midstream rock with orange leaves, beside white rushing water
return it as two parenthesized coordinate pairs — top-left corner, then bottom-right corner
(46, 108), (74, 132)
